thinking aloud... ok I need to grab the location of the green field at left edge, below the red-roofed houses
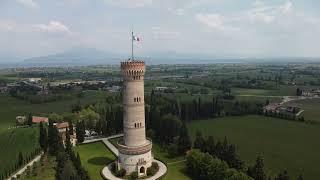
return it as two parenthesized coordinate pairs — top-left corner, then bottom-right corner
(0, 126), (39, 176)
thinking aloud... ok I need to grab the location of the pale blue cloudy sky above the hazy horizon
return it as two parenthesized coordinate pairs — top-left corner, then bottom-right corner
(0, 0), (320, 58)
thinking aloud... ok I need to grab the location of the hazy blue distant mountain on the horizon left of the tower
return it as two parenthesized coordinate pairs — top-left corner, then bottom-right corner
(23, 48), (121, 65)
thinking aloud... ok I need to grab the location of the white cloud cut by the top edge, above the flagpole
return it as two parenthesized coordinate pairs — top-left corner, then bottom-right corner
(104, 0), (152, 8)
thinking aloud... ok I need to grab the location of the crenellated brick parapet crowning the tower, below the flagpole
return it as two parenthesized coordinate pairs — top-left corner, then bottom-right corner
(121, 61), (146, 77)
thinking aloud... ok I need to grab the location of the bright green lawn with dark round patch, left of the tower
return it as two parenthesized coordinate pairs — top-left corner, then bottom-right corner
(75, 142), (115, 180)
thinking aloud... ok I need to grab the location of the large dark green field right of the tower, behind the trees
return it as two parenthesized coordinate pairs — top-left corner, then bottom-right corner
(188, 115), (320, 179)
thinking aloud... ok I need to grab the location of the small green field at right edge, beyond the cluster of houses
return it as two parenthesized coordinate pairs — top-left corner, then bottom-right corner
(287, 99), (320, 122)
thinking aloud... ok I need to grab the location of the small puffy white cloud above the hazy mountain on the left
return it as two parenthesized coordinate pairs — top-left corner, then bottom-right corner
(33, 21), (71, 34)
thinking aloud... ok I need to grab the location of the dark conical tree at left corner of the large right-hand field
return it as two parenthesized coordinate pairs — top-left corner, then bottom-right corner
(178, 123), (192, 153)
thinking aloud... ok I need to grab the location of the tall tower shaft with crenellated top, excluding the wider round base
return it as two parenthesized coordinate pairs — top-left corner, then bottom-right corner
(121, 61), (146, 146)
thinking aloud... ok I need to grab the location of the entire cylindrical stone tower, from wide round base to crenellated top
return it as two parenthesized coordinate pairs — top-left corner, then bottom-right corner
(117, 60), (153, 176)
